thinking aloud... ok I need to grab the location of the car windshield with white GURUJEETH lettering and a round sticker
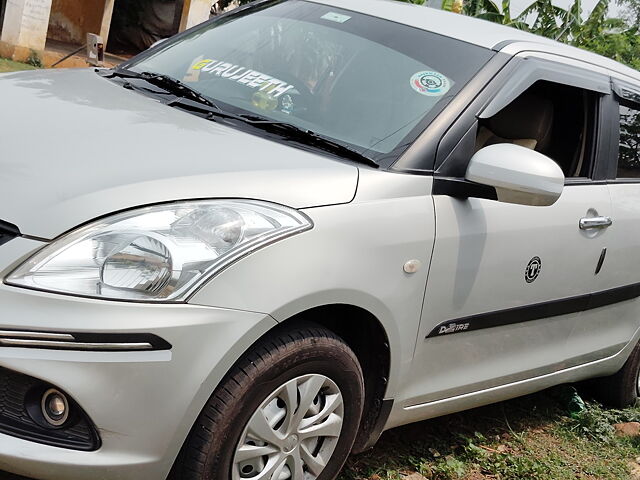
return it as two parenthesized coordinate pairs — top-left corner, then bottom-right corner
(126, 0), (493, 164)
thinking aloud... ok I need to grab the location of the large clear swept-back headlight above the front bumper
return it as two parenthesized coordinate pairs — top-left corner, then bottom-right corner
(6, 200), (312, 301)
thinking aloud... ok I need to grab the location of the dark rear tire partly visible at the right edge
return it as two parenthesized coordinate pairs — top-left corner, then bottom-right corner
(593, 343), (640, 408)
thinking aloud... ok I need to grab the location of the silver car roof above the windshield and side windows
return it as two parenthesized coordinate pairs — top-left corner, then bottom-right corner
(310, 0), (640, 82)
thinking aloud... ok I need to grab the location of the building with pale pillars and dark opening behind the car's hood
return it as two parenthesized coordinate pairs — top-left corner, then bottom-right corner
(0, 0), (212, 63)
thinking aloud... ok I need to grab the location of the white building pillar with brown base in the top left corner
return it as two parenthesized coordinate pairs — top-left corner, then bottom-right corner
(0, 0), (51, 60)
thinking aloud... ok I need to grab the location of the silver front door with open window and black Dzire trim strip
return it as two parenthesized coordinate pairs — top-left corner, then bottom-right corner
(403, 66), (612, 407)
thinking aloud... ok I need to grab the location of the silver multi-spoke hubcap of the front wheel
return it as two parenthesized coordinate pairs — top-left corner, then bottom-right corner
(232, 374), (344, 480)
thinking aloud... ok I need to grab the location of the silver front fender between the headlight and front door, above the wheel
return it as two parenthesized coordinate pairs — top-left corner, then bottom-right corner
(190, 169), (435, 398)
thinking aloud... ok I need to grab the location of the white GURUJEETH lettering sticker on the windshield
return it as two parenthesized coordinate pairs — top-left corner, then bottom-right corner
(191, 59), (295, 98)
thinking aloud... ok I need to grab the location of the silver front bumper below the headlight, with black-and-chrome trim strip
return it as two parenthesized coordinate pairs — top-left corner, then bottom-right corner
(0, 239), (276, 480)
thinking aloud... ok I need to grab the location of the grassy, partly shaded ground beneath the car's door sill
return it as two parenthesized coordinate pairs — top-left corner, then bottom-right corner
(339, 387), (640, 480)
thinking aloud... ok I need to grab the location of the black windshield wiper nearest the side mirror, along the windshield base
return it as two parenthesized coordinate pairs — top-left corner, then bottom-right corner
(168, 98), (380, 168)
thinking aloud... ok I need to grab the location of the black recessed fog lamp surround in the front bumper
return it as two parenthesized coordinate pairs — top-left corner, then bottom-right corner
(0, 367), (100, 451)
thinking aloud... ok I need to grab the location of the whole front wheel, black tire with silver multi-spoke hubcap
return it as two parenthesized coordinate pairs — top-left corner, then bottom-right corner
(172, 324), (364, 480)
